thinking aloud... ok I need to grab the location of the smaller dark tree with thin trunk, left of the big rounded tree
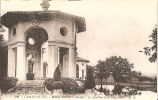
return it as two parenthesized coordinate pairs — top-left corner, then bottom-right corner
(95, 60), (110, 91)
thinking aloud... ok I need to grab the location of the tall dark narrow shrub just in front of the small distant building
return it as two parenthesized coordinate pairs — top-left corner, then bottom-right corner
(84, 66), (95, 89)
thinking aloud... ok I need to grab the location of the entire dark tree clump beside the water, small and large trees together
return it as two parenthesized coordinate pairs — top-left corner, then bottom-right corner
(95, 56), (141, 82)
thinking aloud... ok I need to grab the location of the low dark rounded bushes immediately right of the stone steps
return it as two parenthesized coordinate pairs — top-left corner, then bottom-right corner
(44, 77), (84, 94)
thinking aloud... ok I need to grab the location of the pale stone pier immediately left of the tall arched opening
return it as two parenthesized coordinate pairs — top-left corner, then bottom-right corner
(16, 43), (26, 80)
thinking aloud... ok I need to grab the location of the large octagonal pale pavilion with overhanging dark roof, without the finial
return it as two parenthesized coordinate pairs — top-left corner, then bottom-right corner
(1, 11), (86, 80)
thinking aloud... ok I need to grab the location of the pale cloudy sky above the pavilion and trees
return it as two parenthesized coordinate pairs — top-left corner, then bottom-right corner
(0, 0), (157, 74)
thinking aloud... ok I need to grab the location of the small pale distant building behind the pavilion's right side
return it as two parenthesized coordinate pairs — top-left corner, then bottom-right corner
(76, 57), (89, 80)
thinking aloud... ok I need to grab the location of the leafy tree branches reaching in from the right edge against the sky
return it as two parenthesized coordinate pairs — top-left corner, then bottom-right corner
(139, 28), (157, 62)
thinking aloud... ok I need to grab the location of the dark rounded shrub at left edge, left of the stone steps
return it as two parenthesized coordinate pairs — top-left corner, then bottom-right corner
(0, 77), (18, 92)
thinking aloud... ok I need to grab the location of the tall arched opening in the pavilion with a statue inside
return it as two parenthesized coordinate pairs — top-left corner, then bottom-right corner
(26, 27), (48, 79)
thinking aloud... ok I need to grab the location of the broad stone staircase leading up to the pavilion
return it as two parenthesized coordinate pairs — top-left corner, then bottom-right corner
(9, 80), (46, 94)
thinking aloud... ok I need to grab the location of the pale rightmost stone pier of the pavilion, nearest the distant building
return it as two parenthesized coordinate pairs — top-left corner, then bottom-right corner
(68, 46), (76, 79)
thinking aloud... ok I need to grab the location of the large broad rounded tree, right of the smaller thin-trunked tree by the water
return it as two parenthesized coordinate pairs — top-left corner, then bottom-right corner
(106, 56), (134, 82)
